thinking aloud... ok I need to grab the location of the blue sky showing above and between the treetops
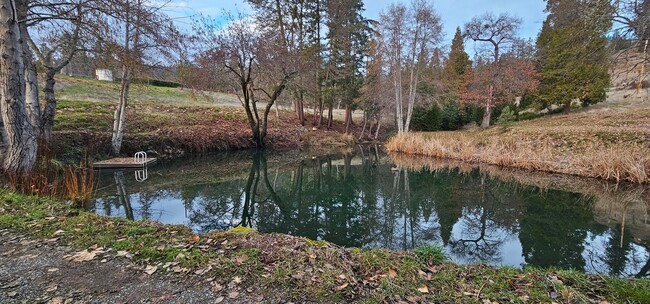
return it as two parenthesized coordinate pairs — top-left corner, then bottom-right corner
(167, 0), (546, 51)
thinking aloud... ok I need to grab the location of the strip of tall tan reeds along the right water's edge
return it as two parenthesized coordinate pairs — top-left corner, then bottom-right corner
(386, 132), (650, 183)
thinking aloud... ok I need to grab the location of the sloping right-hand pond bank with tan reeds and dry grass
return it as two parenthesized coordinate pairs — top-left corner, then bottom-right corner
(386, 99), (650, 183)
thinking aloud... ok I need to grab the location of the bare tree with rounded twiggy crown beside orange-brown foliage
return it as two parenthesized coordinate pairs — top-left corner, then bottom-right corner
(465, 13), (521, 128)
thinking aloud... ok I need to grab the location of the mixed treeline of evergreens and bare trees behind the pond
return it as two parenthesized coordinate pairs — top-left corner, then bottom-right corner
(178, 0), (647, 137)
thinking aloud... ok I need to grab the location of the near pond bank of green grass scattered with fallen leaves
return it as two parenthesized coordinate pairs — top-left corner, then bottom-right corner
(0, 191), (650, 303)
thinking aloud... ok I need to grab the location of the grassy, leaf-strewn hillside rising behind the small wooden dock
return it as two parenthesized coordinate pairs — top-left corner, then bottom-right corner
(54, 76), (352, 158)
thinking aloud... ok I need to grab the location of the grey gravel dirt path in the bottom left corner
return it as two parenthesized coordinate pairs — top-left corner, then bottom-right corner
(0, 230), (270, 304)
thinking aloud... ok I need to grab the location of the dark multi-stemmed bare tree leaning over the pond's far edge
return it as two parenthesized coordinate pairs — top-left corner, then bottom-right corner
(198, 15), (298, 149)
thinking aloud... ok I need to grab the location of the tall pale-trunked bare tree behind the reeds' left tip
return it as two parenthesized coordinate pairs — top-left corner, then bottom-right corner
(380, 0), (442, 133)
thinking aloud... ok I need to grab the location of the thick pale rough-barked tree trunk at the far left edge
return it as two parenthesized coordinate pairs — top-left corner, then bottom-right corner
(0, 0), (37, 174)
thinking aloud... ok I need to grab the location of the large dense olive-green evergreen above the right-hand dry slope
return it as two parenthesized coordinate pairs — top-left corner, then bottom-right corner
(537, 0), (612, 111)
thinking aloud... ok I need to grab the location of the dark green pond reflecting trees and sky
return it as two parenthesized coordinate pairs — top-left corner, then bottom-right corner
(89, 146), (650, 277)
